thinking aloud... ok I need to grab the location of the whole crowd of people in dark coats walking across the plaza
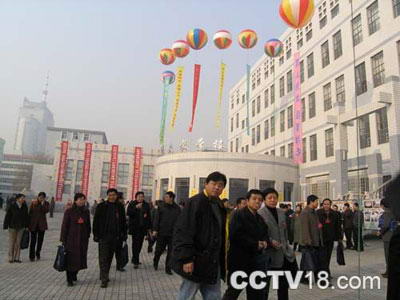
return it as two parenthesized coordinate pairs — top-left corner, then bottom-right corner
(4, 172), (395, 300)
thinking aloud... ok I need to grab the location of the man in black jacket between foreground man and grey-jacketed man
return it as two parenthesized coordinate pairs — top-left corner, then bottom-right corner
(222, 189), (270, 300)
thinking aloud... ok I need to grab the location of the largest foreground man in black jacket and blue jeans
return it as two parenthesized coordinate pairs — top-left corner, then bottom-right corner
(172, 172), (227, 300)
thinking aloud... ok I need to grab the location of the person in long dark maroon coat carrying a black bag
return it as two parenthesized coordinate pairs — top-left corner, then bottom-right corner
(60, 193), (91, 286)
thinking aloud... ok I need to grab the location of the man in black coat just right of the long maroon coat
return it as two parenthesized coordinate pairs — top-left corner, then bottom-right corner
(93, 188), (127, 288)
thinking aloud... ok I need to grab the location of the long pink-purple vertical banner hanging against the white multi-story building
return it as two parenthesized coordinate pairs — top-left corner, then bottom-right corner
(293, 52), (303, 164)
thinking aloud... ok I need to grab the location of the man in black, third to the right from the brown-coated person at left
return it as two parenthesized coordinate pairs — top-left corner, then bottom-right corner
(127, 191), (151, 269)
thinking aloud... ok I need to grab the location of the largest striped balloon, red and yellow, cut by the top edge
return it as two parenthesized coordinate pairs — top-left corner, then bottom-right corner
(279, 0), (315, 28)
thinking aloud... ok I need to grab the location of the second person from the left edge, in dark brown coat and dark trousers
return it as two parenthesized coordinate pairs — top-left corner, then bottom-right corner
(29, 192), (50, 261)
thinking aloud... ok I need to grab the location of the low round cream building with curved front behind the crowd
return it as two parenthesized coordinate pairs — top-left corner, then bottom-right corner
(153, 152), (299, 203)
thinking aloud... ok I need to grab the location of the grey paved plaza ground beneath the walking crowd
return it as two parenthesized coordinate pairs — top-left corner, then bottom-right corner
(0, 210), (386, 300)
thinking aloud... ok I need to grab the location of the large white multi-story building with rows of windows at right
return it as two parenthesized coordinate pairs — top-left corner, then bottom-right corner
(228, 0), (400, 199)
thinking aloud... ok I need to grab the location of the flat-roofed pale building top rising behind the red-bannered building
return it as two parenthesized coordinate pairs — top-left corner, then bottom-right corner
(45, 127), (108, 158)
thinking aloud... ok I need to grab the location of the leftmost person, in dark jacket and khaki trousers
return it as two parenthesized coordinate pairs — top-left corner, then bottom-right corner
(3, 194), (29, 263)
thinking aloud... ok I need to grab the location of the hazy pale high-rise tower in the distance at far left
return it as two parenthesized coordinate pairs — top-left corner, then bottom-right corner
(14, 98), (54, 155)
